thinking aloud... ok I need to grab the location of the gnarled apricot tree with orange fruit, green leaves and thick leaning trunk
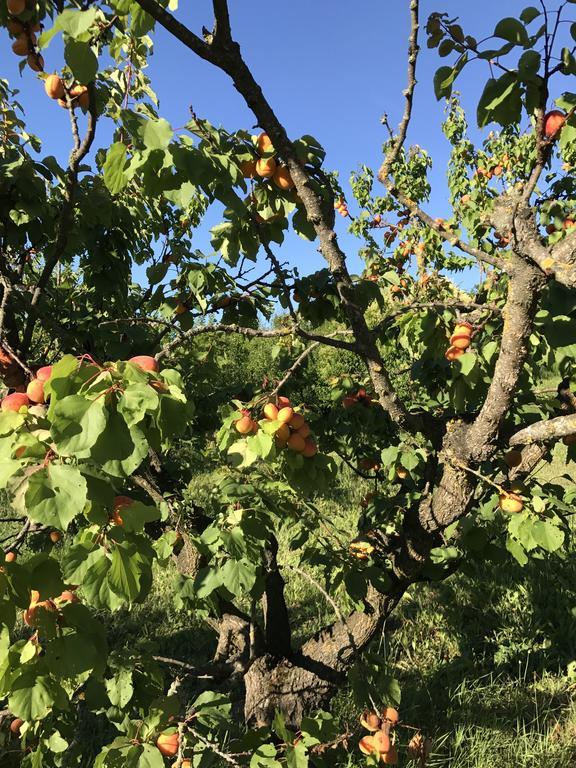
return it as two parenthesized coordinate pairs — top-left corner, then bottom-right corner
(0, 0), (576, 768)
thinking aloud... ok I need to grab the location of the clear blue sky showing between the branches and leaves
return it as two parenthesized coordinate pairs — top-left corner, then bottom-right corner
(2, 0), (548, 292)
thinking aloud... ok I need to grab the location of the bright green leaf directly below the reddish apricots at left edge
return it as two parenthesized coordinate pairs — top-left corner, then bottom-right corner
(50, 395), (108, 459)
